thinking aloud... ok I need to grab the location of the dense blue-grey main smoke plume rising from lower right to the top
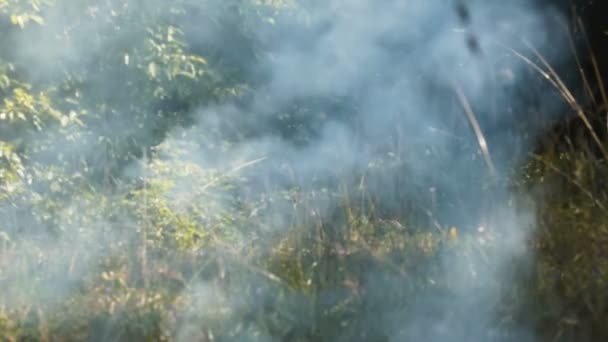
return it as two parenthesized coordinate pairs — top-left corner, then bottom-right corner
(157, 0), (564, 341)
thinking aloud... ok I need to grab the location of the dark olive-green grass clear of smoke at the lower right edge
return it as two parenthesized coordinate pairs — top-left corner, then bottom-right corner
(522, 129), (608, 341)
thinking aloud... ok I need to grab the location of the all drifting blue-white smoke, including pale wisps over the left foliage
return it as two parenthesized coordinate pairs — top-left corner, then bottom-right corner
(0, 0), (576, 342)
